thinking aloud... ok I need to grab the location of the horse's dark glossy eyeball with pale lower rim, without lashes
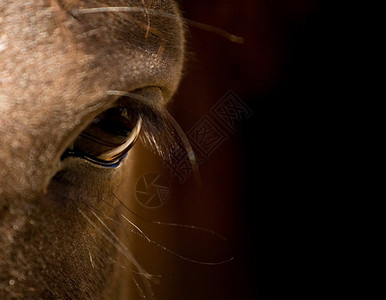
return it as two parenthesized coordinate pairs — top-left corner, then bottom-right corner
(62, 107), (142, 167)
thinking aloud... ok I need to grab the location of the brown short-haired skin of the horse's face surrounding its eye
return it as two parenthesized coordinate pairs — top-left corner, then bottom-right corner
(0, 0), (184, 299)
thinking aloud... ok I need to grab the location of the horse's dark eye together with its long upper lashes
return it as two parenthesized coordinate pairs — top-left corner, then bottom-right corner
(61, 91), (199, 179)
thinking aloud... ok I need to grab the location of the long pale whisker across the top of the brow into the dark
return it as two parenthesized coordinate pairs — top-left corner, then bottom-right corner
(72, 6), (244, 44)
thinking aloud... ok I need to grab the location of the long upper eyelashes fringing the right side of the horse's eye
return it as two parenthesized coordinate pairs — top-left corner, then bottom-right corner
(107, 91), (201, 186)
